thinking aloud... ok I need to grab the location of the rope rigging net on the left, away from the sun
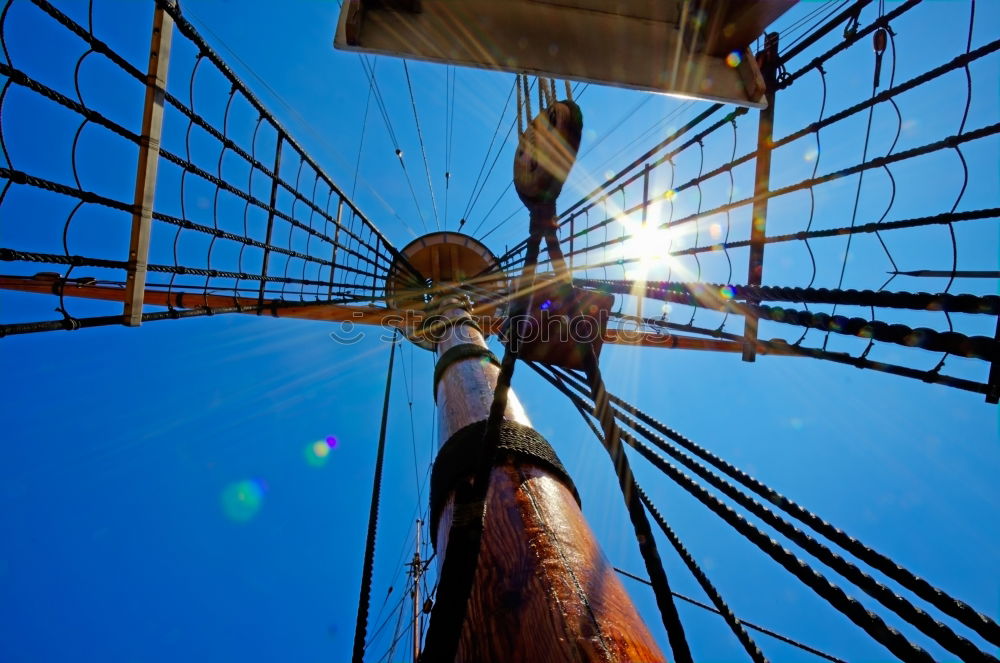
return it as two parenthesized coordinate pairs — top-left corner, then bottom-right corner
(0, 0), (420, 335)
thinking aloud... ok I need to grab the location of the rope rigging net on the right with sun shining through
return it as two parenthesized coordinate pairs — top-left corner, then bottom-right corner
(500, 0), (1000, 402)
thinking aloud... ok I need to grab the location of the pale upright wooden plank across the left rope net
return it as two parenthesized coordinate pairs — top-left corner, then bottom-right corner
(123, 5), (174, 327)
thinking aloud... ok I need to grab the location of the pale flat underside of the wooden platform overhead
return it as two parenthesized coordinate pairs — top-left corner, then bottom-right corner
(334, 0), (776, 108)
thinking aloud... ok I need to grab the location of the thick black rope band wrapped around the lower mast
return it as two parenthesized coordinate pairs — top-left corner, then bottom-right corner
(431, 420), (580, 547)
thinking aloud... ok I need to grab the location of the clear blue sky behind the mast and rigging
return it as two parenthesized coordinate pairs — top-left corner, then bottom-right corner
(0, 0), (1000, 663)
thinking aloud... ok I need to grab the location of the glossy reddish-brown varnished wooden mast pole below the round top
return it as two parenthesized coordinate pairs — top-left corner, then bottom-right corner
(436, 299), (666, 663)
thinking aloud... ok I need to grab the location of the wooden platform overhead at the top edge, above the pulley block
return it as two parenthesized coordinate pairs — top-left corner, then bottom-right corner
(334, 0), (796, 108)
